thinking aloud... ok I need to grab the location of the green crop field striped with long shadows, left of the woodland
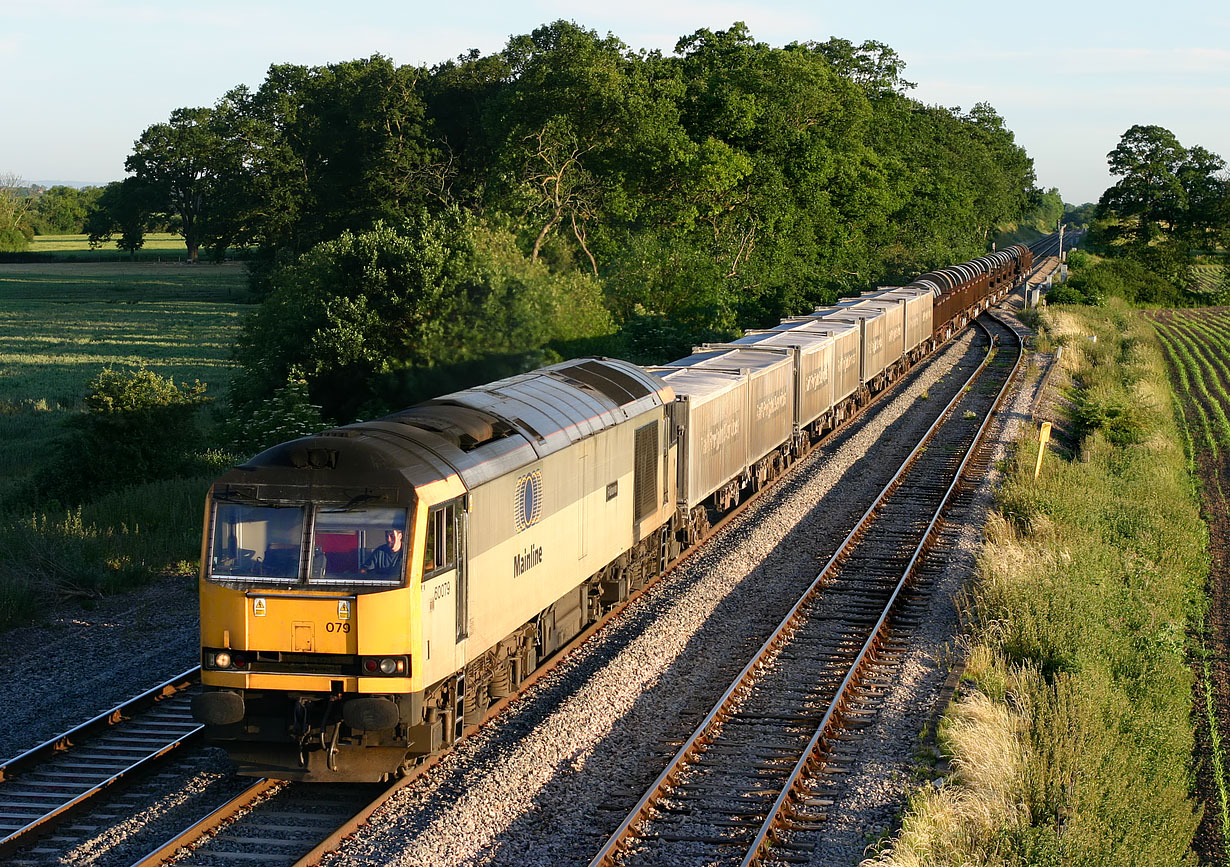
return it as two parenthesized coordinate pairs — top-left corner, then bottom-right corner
(0, 263), (248, 493)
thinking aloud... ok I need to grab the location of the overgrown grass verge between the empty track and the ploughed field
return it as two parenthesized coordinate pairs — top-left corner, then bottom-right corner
(876, 303), (1208, 866)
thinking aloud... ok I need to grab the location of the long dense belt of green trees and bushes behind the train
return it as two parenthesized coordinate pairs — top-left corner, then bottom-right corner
(52, 21), (1055, 432)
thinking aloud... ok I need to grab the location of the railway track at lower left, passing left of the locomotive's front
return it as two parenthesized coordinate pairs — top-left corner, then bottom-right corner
(0, 668), (202, 857)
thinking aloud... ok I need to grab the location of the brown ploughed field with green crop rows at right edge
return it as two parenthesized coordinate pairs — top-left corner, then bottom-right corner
(1150, 307), (1230, 863)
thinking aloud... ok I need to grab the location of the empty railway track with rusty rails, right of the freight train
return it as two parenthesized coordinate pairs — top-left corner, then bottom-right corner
(590, 312), (1022, 867)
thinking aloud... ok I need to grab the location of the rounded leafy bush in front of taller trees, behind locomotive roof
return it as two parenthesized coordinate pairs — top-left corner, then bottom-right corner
(232, 208), (611, 421)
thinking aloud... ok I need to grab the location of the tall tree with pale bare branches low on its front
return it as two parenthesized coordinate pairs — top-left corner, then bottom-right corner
(487, 21), (688, 275)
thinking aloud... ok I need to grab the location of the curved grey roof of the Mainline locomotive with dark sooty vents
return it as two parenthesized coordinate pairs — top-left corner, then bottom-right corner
(231, 358), (674, 489)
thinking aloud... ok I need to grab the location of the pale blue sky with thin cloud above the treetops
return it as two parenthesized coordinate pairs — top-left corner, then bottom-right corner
(0, 0), (1230, 203)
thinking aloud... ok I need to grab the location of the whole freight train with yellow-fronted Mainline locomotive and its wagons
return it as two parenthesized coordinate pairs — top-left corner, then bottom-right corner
(193, 246), (1032, 781)
